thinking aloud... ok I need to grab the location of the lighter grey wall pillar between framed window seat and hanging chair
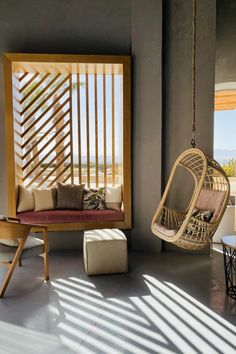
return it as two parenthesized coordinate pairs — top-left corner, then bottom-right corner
(131, 0), (162, 251)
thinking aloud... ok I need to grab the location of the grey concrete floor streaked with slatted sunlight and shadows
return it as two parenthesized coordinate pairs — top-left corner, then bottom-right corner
(0, 251), (236, 354)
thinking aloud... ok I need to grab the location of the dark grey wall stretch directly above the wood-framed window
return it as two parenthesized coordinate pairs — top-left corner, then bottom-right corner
(0, 0), (131, 54)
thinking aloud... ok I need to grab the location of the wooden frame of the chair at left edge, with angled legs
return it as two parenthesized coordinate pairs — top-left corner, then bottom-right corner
(0, 217), (49, 298)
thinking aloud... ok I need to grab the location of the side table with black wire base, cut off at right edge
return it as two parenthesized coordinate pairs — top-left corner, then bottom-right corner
(221, 236), (236, 299)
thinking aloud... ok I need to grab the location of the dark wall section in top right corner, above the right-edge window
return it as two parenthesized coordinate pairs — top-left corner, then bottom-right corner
(215, 0), (236, 83)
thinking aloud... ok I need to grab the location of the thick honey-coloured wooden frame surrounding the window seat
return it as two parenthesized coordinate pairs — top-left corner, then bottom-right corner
(3, 53), (132, 231)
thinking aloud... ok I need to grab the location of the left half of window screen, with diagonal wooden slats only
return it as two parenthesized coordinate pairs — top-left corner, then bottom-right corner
(13, 72), (73, 187)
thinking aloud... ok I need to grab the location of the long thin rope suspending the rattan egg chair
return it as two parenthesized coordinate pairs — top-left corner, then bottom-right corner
(191, 0), (197, 148)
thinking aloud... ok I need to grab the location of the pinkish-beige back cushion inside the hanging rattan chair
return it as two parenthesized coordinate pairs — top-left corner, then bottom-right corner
(196, 188), (226, 222)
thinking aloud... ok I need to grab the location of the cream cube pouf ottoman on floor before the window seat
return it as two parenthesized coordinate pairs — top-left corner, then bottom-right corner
(83, 229), (128, 275)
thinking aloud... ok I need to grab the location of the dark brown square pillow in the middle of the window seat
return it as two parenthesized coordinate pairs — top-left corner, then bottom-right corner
(57, 182), (84, 210)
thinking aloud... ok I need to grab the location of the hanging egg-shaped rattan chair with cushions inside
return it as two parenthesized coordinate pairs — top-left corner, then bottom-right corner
(151, 148), (230, 250)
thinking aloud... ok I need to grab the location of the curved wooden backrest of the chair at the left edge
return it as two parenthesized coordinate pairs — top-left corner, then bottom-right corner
(0, 221), (31, 240)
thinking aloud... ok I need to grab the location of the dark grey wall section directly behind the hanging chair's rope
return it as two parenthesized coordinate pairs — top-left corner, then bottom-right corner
(163, 0), (215, 250)
